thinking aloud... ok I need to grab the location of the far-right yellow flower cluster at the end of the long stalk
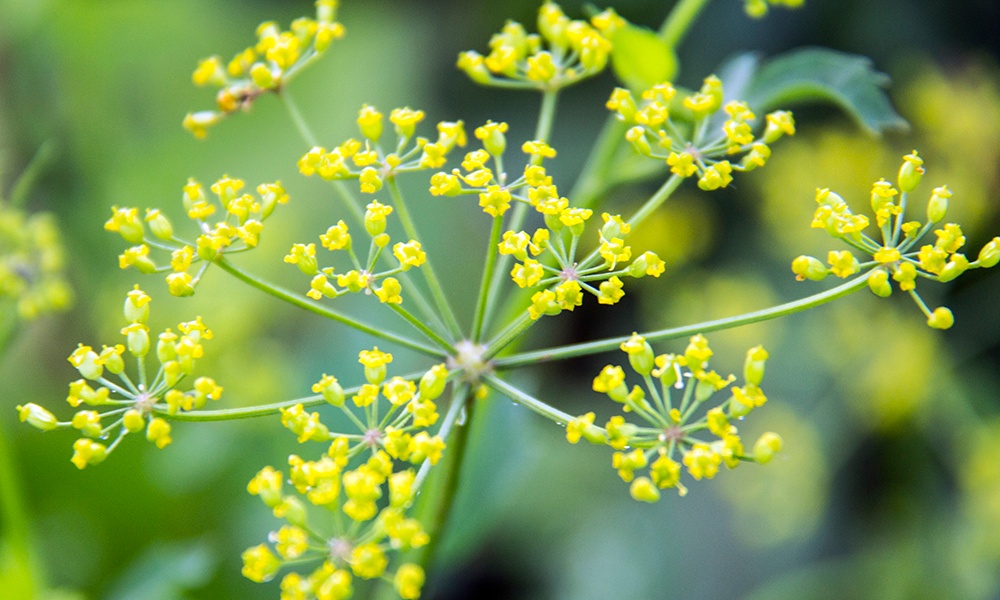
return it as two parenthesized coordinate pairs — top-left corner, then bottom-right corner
(792, 150), (1000, 329)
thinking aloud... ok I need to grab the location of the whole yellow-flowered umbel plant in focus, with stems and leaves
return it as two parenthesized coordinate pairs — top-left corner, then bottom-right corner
(17, 0), (1000, 600)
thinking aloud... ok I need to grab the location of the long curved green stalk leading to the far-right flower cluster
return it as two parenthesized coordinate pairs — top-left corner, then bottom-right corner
(494, 274), (868, 369)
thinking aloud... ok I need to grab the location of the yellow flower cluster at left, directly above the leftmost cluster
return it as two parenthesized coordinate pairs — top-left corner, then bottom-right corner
(104, 175), (288, 296)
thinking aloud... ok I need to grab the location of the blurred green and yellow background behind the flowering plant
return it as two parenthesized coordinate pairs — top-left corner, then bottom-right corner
(0, 0), (1000, 600)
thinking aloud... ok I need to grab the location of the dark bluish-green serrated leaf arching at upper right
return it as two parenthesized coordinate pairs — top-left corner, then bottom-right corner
(744, 48), (909, 135)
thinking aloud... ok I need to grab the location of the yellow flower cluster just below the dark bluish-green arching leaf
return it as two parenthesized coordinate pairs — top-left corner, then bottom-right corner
(606, 75), (795, 191)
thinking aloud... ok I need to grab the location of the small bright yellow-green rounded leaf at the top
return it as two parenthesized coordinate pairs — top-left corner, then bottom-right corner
(611, 23), (677, 91)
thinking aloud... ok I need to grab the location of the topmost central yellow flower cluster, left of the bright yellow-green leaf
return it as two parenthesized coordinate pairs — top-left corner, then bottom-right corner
(458, 2), (611, 90)
